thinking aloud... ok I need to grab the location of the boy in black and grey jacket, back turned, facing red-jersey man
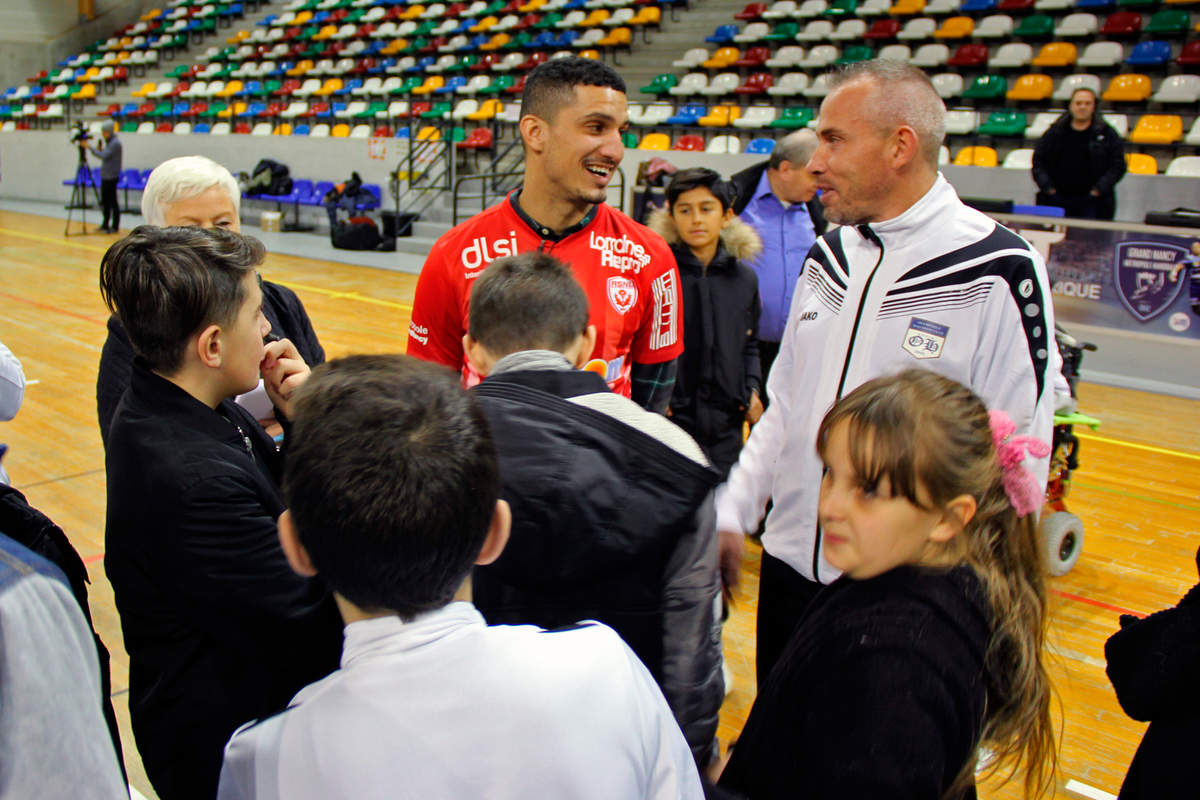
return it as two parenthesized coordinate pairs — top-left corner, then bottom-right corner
(463, 253), (724, 766)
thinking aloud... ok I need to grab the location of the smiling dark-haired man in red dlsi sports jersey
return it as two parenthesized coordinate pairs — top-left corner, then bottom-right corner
(408, 56), (683, 411)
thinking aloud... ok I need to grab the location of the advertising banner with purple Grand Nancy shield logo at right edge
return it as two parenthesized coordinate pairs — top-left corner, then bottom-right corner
(1008, 221), (1200, 339)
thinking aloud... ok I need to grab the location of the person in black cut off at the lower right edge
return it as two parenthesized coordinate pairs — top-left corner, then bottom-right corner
(1104, 551), (1200, 800)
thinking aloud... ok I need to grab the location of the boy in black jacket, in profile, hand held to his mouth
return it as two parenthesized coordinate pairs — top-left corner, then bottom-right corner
(100, 225), (341, 800)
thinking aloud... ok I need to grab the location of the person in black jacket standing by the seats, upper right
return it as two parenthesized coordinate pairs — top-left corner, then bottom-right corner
(1033, 89), (1126, 219)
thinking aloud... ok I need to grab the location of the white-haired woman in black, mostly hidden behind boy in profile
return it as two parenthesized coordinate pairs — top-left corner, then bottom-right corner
(96, 156), (325, 445)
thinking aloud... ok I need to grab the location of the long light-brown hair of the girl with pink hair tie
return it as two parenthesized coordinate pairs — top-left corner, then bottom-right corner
(817, 369), (1055, 796)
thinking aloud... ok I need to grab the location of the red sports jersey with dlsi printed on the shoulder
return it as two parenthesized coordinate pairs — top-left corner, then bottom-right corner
(408, 194), (683, 397)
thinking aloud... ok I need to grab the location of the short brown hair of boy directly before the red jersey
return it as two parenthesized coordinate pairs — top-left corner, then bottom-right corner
(469, 252), (588, 359)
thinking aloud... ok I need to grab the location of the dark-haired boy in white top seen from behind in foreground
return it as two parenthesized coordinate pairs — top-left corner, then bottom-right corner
(218, 355), (701, 800)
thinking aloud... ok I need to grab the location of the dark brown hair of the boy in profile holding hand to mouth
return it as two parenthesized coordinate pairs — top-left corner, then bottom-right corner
(100, 225), (266, 374)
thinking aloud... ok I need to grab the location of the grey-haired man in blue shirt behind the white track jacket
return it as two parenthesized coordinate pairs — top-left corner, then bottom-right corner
(731, 128), (827, 388)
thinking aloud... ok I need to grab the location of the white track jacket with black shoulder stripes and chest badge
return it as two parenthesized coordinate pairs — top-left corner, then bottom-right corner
(716, 175), (1058, 583)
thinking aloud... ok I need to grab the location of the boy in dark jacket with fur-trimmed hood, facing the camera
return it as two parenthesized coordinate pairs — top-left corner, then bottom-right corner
(647, 167), (763, 477)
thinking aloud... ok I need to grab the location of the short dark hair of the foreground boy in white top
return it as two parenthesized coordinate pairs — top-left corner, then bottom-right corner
(283, 355), (500, 619)
